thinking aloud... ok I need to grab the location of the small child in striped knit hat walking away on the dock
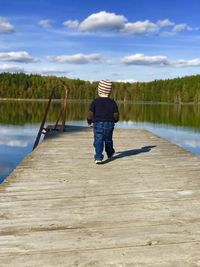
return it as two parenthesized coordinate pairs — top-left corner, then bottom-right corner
(87, 80), (119, 164)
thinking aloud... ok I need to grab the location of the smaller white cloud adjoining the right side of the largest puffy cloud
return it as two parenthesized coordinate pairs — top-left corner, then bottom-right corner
(121, 20), (159, 34)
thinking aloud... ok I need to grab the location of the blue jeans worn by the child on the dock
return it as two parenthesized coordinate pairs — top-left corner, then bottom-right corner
(93, 121), (114, 160)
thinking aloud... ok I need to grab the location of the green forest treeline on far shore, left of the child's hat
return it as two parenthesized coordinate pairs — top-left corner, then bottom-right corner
(0, 73), (97, 99)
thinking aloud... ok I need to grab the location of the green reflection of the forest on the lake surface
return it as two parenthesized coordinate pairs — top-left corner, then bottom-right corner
(0, 101), (200, 131)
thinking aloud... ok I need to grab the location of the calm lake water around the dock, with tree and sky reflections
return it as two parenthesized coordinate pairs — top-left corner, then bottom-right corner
(0, 102), (200, 182)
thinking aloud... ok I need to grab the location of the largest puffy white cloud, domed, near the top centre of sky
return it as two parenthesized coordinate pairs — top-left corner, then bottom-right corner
(79, 11), (127, 32)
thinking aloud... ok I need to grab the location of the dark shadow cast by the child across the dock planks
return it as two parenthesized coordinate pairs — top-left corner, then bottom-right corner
(102, 145), (156, 164)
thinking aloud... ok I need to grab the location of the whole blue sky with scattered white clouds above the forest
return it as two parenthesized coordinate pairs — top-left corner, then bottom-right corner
(0, 0), (200, 82)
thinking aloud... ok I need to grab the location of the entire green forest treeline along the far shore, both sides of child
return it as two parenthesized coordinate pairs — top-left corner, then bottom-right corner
(0, 73), (200, 103)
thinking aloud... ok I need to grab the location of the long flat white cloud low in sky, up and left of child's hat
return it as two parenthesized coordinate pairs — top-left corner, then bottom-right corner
(47, 53), (103, 64)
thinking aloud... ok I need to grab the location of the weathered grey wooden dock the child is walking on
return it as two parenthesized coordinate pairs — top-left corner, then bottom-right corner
(0, 127), (200, 267)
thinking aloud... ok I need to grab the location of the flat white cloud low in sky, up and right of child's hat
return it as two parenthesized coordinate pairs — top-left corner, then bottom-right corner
(122, 54), (169, 66)
